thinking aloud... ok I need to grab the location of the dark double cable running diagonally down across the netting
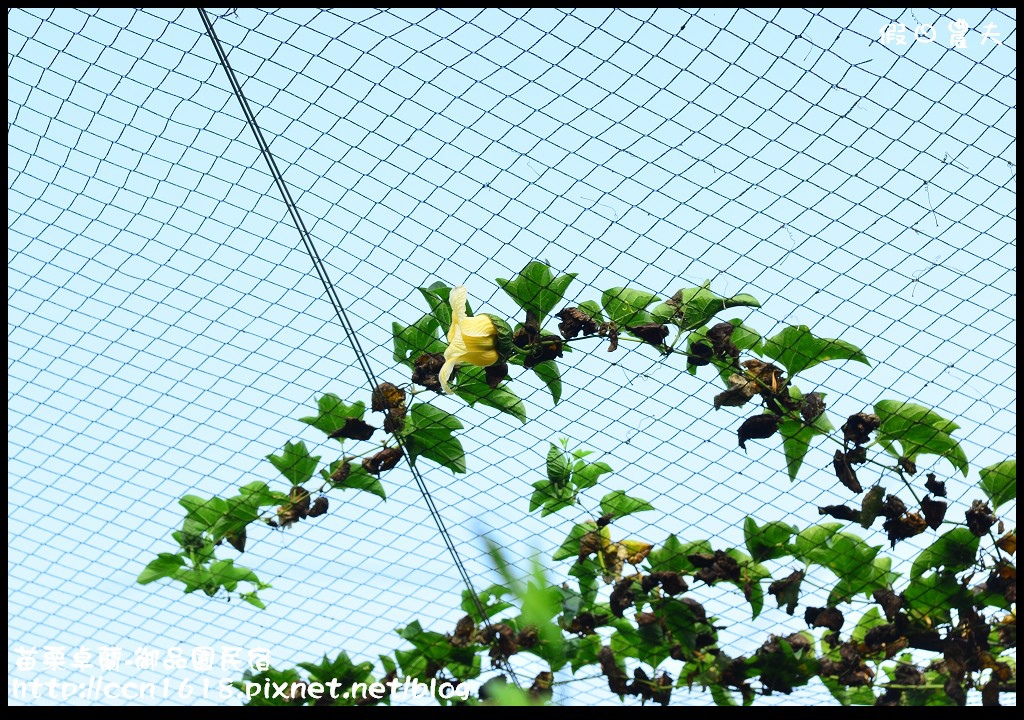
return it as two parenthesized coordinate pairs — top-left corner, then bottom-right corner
(199, 7), (521, 687)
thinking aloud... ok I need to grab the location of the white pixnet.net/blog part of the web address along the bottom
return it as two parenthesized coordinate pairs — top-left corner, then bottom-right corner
(245, 677), (470, 701)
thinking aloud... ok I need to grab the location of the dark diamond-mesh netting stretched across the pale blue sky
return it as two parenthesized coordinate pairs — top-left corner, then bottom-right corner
(8, 8), (1016, 704)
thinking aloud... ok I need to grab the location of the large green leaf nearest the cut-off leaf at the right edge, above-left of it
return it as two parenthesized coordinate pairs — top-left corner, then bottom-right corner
(874, 400), (968, 477)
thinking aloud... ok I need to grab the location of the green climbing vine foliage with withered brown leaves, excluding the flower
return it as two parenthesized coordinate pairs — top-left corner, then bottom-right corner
(138, 261), (1017, 706)
